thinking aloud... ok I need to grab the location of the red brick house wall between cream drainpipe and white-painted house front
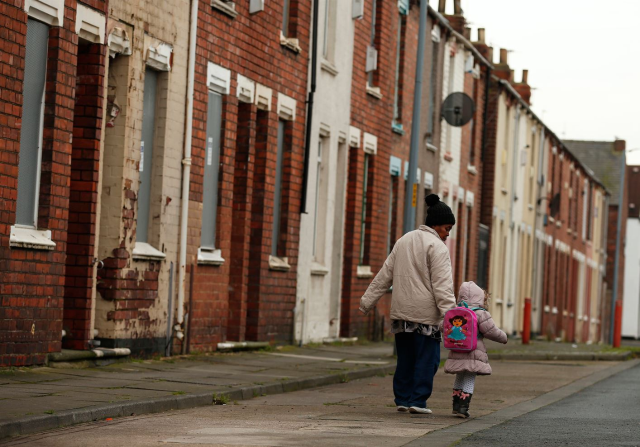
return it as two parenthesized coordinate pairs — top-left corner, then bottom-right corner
(188, 1), (311, 350)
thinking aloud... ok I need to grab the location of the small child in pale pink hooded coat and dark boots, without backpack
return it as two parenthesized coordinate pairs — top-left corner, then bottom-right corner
(444, 281), (507, 418)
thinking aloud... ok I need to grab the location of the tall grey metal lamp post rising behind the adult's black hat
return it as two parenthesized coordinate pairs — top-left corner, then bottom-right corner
(402, 0), (429, 233)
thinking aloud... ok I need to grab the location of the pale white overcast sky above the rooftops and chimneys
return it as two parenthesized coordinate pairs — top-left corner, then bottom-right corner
(458, 0), (640, 164)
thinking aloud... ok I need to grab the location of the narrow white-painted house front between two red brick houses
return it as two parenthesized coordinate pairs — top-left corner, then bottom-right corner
(295, 0), (355, 343)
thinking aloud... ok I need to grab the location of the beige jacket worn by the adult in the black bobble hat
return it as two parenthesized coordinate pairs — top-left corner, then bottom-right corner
(360, 225), (456, 325)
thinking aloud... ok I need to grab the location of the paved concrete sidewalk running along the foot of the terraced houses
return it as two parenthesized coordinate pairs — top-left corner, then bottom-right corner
(0, 340), (625, 439)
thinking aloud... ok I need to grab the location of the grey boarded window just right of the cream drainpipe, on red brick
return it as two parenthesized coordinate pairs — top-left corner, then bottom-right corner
(200, 92), (222, 250)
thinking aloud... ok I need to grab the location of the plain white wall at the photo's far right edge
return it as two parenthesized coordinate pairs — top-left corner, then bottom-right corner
(622, 218), (640, 338)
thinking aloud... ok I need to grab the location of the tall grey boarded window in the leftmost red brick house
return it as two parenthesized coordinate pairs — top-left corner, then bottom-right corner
(16, 19), (49, 226)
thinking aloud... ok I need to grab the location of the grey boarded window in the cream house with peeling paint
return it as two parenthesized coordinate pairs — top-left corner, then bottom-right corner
(136, 68), (158, 242)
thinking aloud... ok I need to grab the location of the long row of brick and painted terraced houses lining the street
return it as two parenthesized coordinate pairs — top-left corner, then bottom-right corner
(0, 0), (612, 366)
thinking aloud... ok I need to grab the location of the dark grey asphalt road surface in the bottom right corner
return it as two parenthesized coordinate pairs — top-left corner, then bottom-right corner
(456, 366), (640, 447)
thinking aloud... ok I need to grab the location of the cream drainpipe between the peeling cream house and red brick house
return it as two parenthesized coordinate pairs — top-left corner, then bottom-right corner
(174, 0), (198, 340)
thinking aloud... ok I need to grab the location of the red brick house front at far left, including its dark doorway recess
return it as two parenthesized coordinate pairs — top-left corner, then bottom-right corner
(0, 0), (107, 365)
